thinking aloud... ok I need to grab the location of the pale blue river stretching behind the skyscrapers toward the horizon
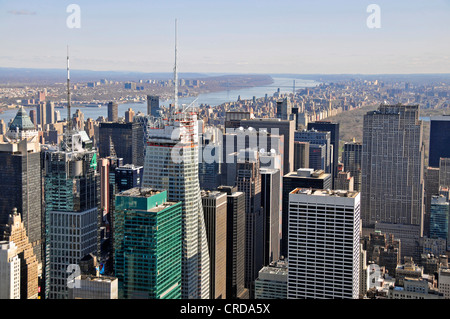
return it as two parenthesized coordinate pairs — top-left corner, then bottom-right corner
(0, 77), (320, 123)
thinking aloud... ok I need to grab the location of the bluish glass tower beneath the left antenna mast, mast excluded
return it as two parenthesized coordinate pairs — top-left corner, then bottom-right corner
(43, 131), (101, 299)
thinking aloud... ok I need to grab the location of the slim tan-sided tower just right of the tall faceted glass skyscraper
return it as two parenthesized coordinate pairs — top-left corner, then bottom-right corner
(202, 191), (227, 299)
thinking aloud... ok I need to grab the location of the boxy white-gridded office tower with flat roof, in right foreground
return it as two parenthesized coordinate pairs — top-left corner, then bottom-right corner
(287, 188), (360, 299)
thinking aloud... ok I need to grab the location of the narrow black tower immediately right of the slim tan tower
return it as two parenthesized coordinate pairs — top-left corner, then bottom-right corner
(217, 186), (248, 299)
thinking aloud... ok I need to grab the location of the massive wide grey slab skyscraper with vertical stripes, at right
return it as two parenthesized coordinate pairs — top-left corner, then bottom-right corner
(361, 104), (424, 257)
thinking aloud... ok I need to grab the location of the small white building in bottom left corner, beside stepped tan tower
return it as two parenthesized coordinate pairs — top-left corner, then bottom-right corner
(0, 241), (20, 299)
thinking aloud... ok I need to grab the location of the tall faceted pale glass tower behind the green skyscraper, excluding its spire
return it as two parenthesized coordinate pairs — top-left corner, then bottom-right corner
(142, 112), (209, 299)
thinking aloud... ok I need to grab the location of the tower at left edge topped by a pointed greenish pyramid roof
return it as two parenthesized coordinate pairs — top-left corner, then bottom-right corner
(0, 108), (43, 263)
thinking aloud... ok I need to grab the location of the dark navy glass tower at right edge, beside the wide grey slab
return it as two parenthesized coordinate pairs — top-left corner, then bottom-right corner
(428, 115), (450, 167)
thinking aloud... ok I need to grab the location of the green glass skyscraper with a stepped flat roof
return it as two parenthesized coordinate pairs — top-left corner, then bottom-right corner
(114, 187), (182, 299)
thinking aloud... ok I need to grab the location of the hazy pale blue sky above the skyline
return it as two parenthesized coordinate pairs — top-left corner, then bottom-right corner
(0, 0), (450, 74)
